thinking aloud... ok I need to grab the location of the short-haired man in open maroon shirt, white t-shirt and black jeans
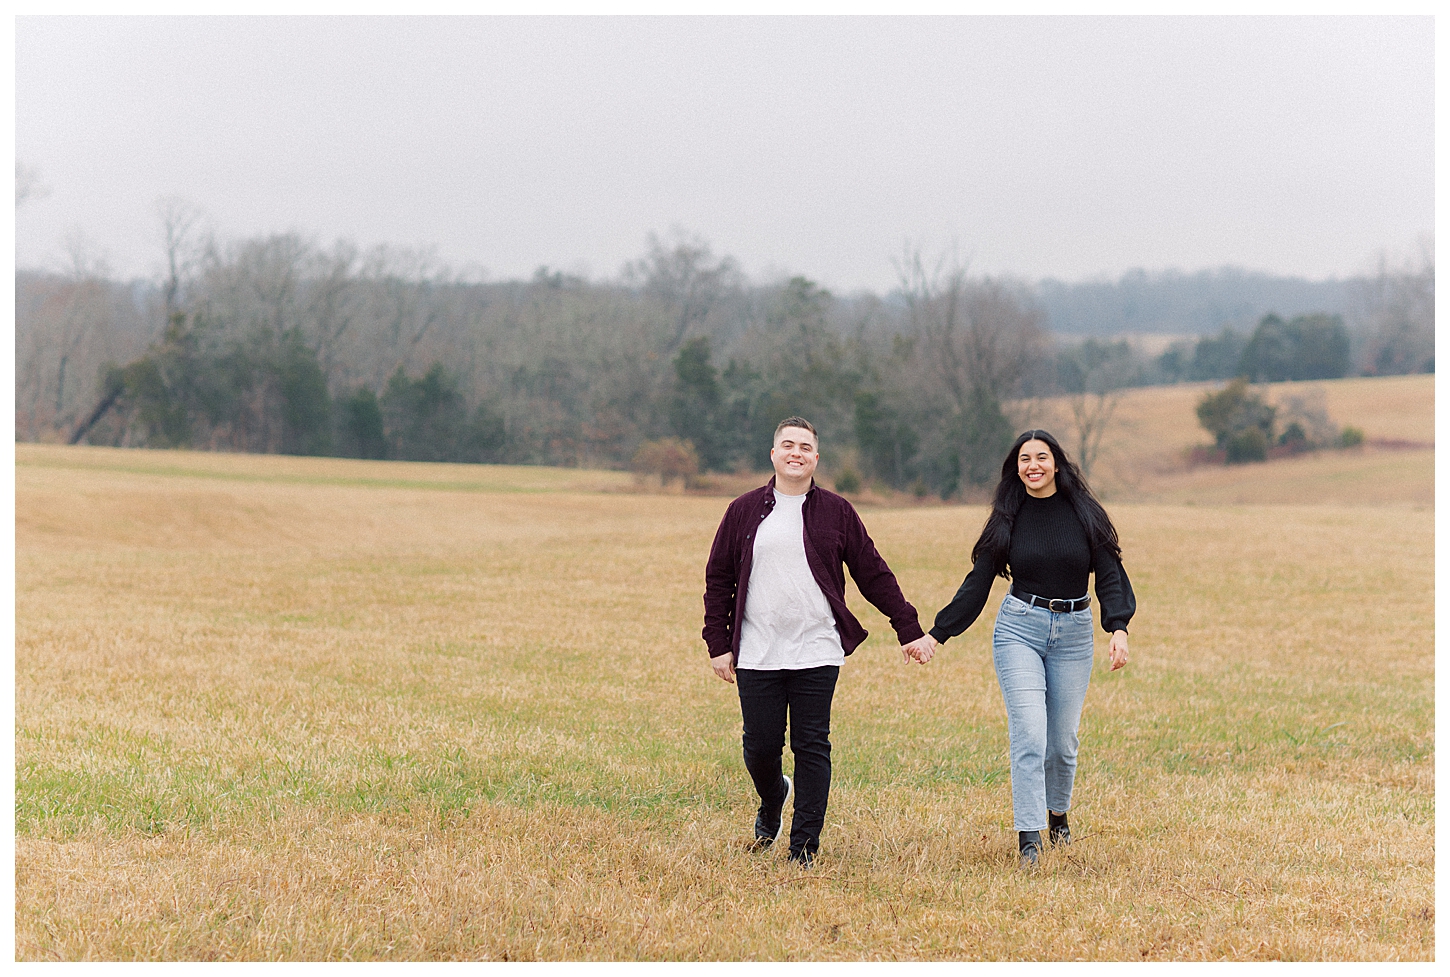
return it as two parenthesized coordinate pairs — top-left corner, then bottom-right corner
(702, 417), (927, 867)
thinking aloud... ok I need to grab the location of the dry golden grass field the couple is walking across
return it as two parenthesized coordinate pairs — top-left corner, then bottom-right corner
(15, 381), (1434, 960)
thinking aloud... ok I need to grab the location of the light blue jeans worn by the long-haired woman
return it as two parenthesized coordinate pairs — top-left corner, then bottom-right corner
(992, 594), (1092, 831)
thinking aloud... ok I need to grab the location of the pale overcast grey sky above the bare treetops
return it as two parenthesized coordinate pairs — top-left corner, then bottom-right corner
(16, 17), (1434, 291)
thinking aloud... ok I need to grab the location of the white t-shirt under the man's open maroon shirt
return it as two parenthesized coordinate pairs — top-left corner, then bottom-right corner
(737, 489), (845, 670)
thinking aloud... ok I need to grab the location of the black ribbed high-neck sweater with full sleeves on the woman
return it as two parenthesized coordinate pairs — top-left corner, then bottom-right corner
(931, 491), (1132, 642)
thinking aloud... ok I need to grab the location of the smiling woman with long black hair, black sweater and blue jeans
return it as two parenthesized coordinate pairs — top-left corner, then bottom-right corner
(914, 431), (1135, 865)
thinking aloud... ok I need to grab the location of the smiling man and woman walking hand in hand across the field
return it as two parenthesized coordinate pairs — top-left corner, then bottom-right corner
(702, 417), (1135, 867)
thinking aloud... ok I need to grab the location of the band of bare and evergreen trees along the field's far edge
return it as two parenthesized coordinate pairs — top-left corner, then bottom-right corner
(16, 204), (1433, 497)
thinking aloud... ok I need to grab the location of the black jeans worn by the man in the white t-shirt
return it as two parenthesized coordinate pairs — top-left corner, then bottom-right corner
(735, 665), (841, 855)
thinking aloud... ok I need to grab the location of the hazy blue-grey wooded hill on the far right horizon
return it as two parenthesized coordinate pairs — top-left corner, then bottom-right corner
(1035, 268), (1362, 336)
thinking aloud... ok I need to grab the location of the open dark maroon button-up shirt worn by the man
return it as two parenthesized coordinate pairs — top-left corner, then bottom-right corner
(700, 475), (922, 660)
